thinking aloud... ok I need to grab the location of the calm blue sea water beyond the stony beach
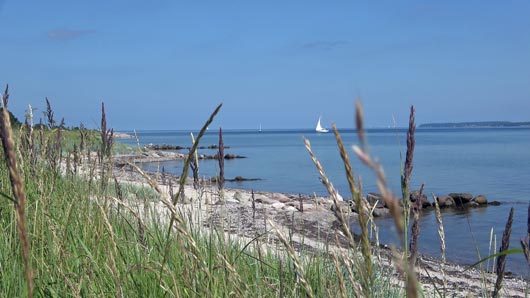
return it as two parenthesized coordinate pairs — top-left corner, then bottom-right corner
(117, 128), (530, 276)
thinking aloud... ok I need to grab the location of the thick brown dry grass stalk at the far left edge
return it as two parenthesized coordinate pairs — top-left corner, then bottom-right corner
(0, 86), (34, 297)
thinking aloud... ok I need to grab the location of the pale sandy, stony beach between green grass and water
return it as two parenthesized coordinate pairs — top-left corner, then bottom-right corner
(110, 152), (528, 297)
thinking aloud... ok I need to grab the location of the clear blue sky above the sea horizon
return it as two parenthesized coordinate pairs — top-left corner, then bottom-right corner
(0, 0), (530, 130)
